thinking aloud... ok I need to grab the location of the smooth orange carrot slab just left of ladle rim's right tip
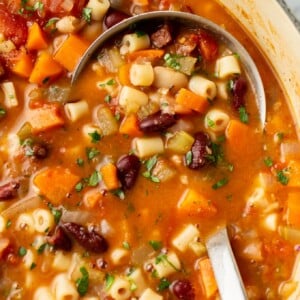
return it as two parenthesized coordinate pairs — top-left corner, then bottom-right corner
(225, 119), (251, 155)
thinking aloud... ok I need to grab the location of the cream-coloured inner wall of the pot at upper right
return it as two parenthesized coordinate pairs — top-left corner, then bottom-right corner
(219, 0), (300, 138)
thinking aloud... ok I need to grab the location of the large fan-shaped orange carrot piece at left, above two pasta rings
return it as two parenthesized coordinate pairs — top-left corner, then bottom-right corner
(33, 166), (80, 205)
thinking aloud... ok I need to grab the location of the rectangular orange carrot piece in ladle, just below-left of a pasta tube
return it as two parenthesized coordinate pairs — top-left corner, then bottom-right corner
(175, 88), (209, 113)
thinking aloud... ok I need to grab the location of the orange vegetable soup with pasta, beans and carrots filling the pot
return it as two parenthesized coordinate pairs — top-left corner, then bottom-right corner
(0, 0), (300, 300)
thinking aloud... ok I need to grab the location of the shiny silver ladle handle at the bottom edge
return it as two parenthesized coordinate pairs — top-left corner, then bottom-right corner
(206, 228), (248, 300)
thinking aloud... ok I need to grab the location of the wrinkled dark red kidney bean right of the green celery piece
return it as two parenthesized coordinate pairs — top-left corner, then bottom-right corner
(185, 131), (211, 170)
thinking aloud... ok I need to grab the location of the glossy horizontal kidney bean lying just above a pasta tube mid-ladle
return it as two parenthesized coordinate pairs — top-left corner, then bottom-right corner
(139, 112), (176, 133)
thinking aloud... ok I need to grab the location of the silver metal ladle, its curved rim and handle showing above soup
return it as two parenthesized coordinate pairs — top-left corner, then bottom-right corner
(72, 9), (266, 300)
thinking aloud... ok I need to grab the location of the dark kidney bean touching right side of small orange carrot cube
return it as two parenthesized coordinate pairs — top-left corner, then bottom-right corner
(117, 154), (141, 189)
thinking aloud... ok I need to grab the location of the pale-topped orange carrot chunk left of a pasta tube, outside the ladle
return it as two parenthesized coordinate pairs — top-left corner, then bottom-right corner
(28, 103), (65, 134)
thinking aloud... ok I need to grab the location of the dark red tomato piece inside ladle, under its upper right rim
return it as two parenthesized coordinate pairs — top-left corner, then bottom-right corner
(199, 31), (219, 61)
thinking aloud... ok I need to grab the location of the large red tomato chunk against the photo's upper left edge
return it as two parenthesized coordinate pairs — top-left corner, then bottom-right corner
(0, 4), (28, 47)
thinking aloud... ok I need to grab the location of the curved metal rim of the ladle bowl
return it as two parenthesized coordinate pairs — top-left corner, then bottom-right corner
(71, 11), (266, 127)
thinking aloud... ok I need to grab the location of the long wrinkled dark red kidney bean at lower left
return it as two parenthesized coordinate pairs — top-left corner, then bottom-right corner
(64, 222), (108, 253)
